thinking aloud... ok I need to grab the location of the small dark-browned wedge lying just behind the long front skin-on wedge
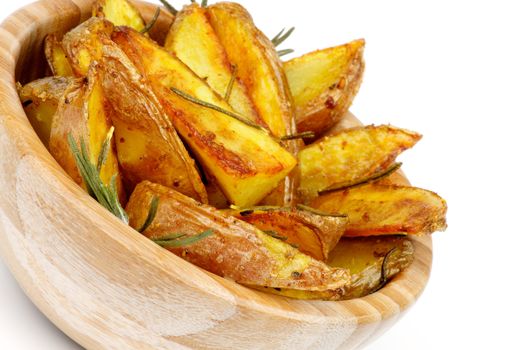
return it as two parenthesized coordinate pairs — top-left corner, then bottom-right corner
(226, 207), (347, 261)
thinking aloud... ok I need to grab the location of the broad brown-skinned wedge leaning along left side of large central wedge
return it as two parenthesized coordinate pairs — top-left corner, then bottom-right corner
(101, 41), (207, 203)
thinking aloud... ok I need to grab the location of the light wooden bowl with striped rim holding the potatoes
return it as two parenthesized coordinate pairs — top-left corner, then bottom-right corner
(0, 0), (432, 350)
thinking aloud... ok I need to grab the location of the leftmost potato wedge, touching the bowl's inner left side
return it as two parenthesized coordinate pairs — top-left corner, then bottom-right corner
(18, 77), (74, 147)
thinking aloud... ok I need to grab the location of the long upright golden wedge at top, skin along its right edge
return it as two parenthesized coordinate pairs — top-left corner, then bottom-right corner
(207, 2), (296, 137)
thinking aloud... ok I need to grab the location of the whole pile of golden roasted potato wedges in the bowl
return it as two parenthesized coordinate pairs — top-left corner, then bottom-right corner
(19, 0), (447, 300)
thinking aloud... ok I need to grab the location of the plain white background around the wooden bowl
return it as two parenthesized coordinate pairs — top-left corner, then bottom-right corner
(0, 0), (528, 350)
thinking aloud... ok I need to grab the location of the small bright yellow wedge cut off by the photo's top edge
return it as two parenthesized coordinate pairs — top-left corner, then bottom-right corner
(92, 0), (145, 31)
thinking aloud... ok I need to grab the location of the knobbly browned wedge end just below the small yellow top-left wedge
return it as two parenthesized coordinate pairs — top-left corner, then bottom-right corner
(62, 17), (114, 77)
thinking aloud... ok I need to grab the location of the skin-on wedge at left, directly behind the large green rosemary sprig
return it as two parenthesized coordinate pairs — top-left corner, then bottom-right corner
(50, 65), (125, 202)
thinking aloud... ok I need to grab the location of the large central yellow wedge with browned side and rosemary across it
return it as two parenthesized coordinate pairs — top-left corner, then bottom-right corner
(112, 27), (297, 207)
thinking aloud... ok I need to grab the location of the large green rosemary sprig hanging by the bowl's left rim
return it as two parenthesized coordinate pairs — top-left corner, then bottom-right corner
(68, 133), (128, 225)
